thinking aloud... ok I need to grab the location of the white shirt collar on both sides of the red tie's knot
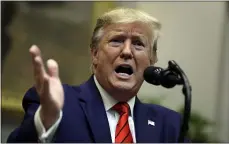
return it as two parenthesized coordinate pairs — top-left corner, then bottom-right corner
(94, 75), (136, 117)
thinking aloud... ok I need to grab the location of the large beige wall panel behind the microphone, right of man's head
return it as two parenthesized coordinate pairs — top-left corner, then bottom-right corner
(131, 2), (226, 141)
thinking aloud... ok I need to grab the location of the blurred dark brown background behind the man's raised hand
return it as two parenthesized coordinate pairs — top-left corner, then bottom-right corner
(1, 1), (93, 142)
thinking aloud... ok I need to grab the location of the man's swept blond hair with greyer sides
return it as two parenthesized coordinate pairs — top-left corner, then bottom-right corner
(90, 8), (161, 49)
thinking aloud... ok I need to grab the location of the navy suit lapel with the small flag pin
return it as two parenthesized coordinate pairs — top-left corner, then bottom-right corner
(134, 98), (162, 143)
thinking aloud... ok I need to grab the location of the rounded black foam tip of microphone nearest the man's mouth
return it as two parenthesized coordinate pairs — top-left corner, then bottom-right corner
(143, 66), (163, 85)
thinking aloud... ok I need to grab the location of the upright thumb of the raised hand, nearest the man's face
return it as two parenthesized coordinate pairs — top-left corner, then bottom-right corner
(47, 59), (59, 78)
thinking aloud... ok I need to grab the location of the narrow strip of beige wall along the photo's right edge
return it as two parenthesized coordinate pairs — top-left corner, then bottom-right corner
(215, 10), (229, 142)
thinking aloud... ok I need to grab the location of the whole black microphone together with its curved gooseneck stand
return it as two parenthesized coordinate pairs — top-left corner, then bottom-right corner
(143, 60), (192, 143)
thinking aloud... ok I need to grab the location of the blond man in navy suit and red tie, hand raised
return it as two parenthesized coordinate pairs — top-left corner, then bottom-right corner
(8, 8), (188, 143)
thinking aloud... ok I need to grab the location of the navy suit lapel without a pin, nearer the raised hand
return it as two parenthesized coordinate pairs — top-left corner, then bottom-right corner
(80, 76), (112, 143)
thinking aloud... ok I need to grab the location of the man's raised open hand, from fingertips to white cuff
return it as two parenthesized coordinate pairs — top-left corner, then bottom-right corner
(29, 45), (64, 129)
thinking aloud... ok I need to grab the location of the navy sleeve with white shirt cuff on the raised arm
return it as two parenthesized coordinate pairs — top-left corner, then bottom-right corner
(7, 87), (62, 143)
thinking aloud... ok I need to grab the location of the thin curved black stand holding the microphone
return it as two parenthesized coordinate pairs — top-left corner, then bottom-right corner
(168, 60), (192, 143)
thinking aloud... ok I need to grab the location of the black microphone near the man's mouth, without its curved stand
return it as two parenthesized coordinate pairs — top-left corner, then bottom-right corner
(143, 66), (183, 88)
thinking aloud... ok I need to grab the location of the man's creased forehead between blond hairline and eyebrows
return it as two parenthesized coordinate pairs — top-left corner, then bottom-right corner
(104, 22), (152, 39)
